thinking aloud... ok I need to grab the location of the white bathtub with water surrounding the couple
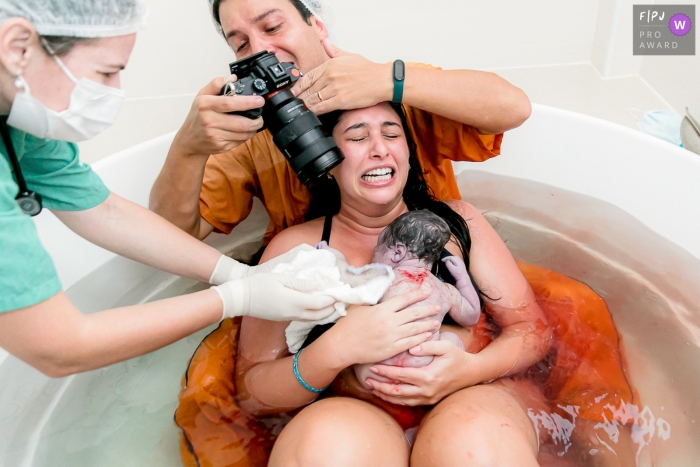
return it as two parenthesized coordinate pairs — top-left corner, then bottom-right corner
(0, 106), (700, 467)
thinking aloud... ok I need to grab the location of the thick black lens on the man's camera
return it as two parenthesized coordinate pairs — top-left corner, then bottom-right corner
(263, 89), (343, 183)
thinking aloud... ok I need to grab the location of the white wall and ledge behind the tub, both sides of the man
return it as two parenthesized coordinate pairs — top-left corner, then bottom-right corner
(81, 0), (700, 162)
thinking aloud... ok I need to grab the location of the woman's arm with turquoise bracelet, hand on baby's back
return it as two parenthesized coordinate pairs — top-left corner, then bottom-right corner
(236, 224), (439, 415)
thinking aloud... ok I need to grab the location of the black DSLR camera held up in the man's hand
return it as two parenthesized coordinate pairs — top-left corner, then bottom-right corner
(221, 50), (344, 184)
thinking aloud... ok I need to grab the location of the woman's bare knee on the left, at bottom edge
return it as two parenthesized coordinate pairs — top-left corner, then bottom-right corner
(269, 397), (408, 467)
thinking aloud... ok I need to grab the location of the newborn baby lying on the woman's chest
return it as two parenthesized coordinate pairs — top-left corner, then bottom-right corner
(320, 211), (481, 385)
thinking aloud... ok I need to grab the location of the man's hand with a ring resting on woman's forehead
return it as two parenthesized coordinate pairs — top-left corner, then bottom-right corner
(292, 39), (394, 115)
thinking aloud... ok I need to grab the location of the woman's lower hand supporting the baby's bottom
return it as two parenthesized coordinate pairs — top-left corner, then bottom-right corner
(367, 341), (483, 406)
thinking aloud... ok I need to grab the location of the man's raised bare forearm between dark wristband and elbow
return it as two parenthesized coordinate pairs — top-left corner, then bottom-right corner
(403, 67), (532, 134)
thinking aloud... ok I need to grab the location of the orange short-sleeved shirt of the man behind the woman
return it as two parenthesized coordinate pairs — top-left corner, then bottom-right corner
(199, 102), (503, 244)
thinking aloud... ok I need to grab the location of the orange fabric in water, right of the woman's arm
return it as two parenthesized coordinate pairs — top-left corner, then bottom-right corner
(518, 263), (638, 422)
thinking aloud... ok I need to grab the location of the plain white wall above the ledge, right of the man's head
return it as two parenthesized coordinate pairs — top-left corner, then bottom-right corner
(326, 0), (598, 69)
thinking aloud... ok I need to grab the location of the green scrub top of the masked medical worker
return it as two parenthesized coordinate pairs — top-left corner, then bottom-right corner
(0, 127), (109, 313)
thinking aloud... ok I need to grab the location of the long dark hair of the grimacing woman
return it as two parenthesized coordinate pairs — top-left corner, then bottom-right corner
(306, 103), (483, 295)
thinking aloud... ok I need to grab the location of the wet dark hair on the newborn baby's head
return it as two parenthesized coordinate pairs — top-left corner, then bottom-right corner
(379, 210), (451, 265)
